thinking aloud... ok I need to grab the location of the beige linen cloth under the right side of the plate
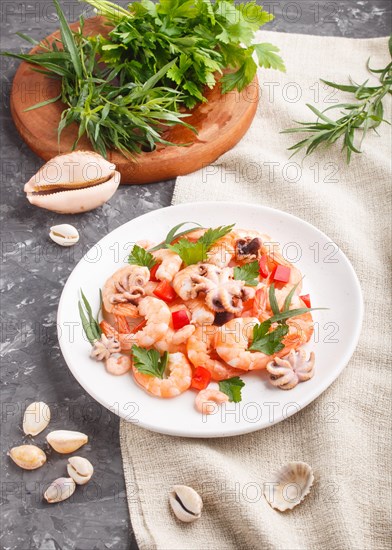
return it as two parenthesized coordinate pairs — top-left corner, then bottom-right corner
(120, 32), (391, 550)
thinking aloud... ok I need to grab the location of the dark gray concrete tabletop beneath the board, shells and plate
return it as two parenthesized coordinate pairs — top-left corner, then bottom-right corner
(0, 0), (392, 550)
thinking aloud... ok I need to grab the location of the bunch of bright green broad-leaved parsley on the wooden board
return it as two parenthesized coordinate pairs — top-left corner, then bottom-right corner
(84, 0), (285, 108)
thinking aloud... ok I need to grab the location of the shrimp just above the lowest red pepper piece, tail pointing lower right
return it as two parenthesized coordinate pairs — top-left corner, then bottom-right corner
(186, 326), (238, 381)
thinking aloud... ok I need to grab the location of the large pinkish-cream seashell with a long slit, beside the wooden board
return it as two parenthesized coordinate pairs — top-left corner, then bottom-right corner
(24, 151), (120, 214)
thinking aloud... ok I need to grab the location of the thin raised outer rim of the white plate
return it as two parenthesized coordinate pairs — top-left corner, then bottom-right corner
(56, 200), (364, 439)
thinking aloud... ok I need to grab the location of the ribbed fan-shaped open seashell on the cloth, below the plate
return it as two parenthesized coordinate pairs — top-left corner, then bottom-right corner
(264, 462), (314, 512)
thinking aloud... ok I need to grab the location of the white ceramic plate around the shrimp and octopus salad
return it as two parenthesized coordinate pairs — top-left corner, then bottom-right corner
(58, 202), (363, 437)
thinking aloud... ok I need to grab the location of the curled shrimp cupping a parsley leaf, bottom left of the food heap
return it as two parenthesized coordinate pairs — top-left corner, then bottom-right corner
(132, 353), (192, 397)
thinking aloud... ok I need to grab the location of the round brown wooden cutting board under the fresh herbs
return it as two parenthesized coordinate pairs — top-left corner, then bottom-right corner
(11, 17), (259, 183)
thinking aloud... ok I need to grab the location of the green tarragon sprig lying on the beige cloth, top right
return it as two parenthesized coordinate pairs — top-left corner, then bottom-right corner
(281, 36), (392, 164)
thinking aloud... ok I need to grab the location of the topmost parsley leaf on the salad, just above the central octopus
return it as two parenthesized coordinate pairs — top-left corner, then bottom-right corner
(167, 224), (234, 265)
